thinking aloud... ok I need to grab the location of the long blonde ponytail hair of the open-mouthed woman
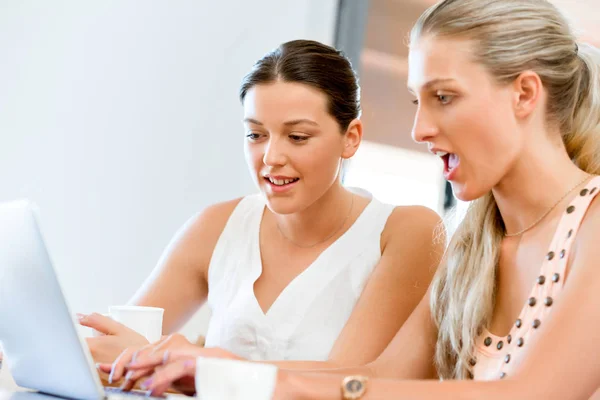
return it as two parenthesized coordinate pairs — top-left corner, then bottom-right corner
(410, 0), (600, 379)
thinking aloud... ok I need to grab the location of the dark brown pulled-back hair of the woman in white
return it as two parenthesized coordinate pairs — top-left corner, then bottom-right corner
(240, 40), (360, 132)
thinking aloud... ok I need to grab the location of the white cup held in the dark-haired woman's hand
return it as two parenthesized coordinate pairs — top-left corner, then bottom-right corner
(109, 306), (165, 343)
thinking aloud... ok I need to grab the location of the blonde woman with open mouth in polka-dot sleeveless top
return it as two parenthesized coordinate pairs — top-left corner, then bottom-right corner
(120, 0), (600, 400)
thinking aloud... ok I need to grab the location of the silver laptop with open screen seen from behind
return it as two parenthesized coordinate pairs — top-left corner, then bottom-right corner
(0, 200), (162, 399)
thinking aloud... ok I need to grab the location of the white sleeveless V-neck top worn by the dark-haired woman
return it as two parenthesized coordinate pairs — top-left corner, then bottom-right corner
(206, 189), (394, 361)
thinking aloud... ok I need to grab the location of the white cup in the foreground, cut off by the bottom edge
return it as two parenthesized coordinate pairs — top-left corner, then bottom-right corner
(195, 357), (277, 400)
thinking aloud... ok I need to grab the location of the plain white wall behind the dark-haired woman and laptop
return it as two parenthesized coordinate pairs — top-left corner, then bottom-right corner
(0, 0), (337, 336)
